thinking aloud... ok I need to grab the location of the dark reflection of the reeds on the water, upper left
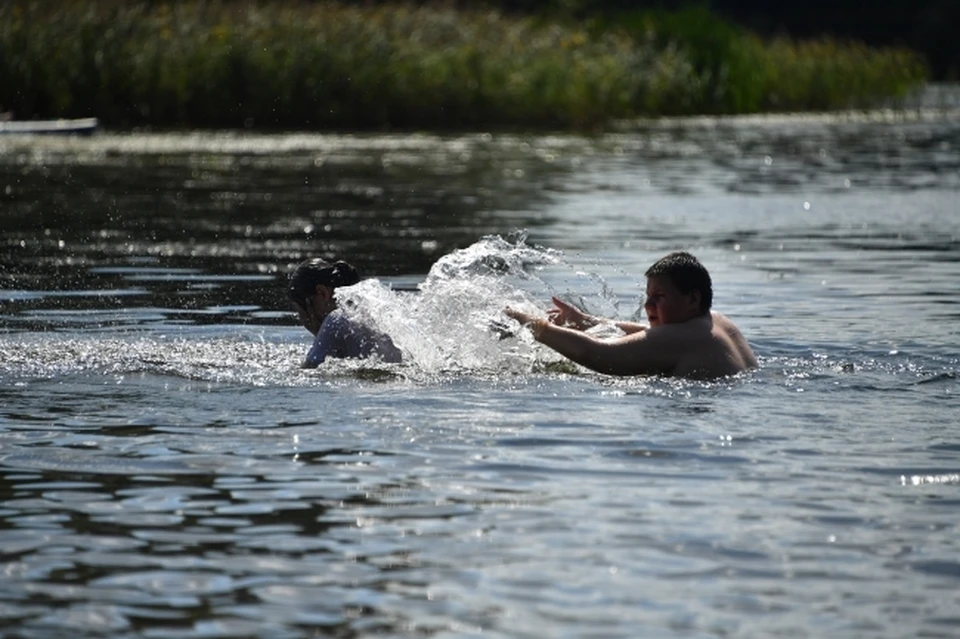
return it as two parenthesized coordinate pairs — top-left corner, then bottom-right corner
(0, 134), (589, 323)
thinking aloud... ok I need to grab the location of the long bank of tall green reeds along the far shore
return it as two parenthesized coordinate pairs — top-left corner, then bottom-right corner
(0, 1), (926, 130)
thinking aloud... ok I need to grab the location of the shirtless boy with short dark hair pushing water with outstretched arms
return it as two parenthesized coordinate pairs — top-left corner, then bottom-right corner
(505, 252), (757, 379)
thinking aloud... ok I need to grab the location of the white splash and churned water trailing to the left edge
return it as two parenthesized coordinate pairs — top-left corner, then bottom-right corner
(0, 234), (632, 386)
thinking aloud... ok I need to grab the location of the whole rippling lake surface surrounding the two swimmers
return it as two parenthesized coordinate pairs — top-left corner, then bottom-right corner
(0, 92), (960, 639)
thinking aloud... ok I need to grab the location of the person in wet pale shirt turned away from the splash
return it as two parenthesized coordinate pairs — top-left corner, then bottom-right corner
(287, 258), (402, 368)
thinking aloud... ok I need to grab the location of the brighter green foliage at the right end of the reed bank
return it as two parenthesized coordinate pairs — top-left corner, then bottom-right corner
(599, 6), (927, 113)
